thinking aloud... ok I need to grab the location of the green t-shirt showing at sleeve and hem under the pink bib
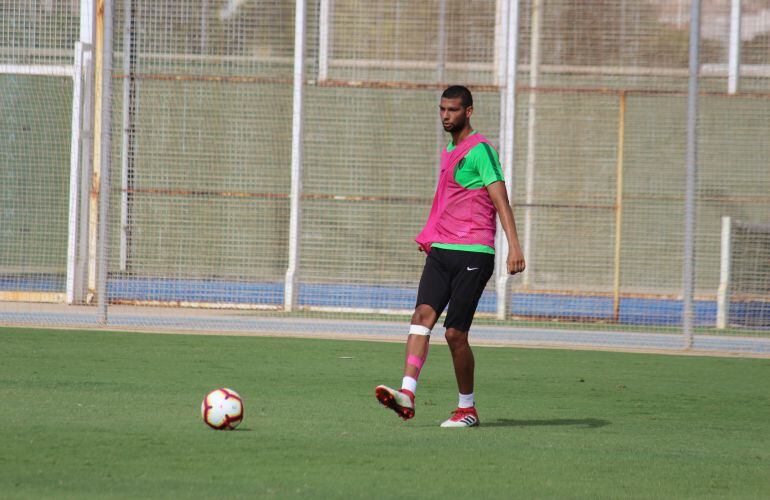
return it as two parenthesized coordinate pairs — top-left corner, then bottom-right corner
(432, 132), (503, 254)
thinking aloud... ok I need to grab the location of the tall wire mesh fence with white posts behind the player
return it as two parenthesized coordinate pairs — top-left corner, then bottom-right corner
(0, 0), (770, 348)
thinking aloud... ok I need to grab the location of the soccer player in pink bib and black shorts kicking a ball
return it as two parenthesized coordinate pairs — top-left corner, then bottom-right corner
(375, 85), (524, 427)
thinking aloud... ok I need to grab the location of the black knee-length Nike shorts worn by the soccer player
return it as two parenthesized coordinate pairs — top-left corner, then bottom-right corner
(417, 248), (495, 332)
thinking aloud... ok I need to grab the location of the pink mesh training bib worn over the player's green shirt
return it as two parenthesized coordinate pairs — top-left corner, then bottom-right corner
(415, 133), (497, 253)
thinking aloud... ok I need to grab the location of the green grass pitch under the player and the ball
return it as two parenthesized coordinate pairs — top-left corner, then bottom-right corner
(0, 329), (770, 498)
